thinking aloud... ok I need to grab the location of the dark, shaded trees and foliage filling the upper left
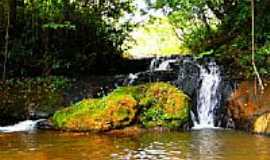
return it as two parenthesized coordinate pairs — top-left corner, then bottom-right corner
(0, 0), (132, 76)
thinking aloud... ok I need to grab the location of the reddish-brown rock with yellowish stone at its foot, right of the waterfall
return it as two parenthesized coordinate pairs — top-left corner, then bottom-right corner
(228, 81), (270, 133)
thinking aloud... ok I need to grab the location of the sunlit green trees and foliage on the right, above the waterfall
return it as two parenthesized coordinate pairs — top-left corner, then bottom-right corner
(152, 0), (270, 77)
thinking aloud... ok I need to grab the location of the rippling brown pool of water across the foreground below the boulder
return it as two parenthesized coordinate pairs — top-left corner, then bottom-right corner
(0, 130), (270, 160)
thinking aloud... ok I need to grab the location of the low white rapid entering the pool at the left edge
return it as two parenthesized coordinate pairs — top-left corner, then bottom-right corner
(0, 119), (45, 133)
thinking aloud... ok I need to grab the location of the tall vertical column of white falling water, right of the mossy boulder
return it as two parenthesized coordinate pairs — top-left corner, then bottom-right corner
(193, 62), (221, 129)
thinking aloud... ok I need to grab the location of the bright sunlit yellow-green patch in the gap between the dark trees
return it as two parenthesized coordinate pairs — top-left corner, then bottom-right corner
(126, 16), (189, 57)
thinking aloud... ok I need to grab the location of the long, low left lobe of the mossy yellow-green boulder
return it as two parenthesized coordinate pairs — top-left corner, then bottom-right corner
(52, 95), (137, 131)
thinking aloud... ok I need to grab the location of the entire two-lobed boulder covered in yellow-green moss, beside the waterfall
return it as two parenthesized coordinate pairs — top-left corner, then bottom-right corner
(51, 83), (190, 131)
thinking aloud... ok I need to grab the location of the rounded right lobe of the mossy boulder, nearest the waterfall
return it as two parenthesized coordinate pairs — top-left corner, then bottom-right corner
(140, 83), (190, 129)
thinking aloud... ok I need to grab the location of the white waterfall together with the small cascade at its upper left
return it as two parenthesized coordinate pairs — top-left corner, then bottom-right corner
(148, 58), (221, 129)
